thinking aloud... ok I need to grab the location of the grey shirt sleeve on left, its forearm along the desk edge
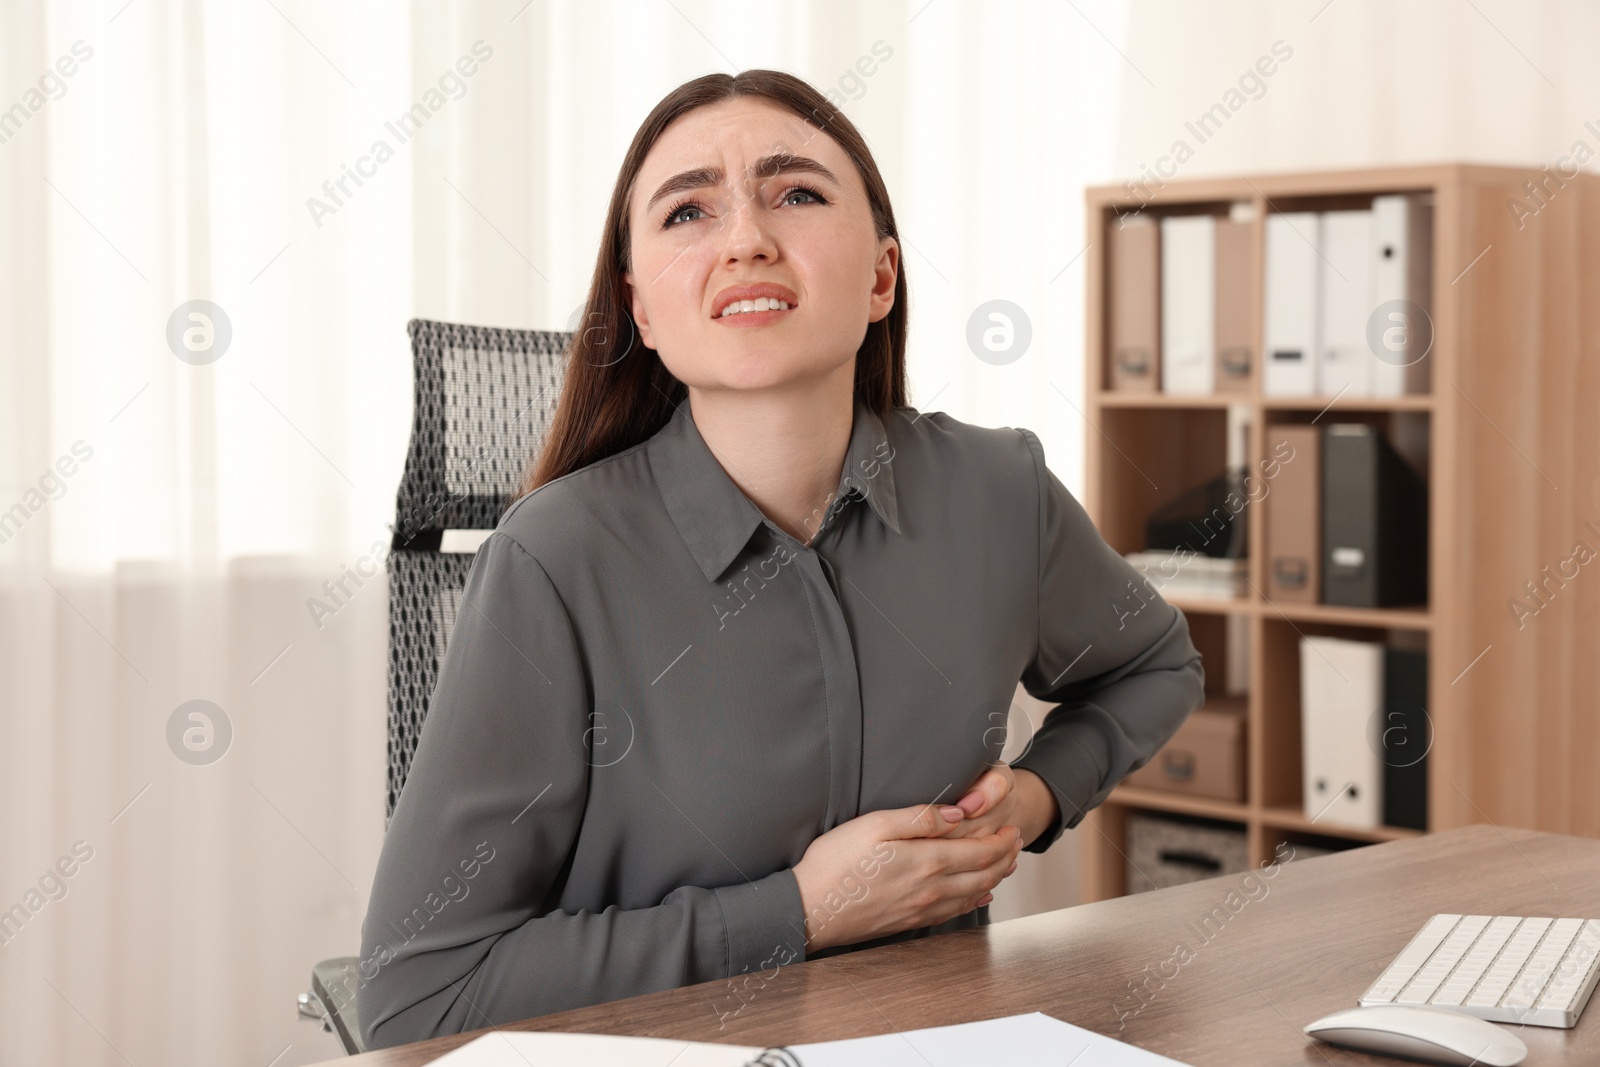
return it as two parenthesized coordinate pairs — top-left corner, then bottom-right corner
(355, 531), (805, 1048)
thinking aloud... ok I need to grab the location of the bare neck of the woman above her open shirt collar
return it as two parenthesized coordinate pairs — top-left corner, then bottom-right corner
(688, 360), (856, 544)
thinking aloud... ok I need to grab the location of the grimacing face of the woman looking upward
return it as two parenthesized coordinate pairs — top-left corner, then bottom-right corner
(624, 98), (899, 396)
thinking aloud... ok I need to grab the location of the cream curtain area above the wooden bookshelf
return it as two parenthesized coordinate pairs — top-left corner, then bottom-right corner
(1115, 0), (1600, 184)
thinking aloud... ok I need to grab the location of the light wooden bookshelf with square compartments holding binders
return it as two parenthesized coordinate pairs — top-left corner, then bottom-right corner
(1078, 165), (1600, 901)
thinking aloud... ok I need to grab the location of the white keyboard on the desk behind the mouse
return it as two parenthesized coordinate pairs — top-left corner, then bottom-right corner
(1358, 915), (1600, 1027)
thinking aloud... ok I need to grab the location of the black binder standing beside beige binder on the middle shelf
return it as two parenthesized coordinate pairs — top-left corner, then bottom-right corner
(1322, 422), (1427, 608)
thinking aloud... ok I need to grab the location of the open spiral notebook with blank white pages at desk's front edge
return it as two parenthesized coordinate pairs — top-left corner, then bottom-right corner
(432, 1011), (1187, 1067)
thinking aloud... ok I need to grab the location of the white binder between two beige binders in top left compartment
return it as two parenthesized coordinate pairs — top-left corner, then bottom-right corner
(1162, 214), (1216, 395)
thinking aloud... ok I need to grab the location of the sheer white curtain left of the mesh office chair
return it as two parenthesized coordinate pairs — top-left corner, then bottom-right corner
(0, 0), (411, 1067)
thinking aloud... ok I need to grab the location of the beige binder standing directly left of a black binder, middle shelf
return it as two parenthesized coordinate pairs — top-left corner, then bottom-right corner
(1266, 426), (1322, 603)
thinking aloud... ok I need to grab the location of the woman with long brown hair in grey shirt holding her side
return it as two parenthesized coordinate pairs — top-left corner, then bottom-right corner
(357, 70), (1203, 1048)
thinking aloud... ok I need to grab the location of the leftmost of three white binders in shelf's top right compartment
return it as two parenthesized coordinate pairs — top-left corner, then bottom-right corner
(1261, 211), (1322, 397)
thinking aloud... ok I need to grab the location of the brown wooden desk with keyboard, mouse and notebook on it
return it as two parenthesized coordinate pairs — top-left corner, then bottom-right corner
(330, 825), (1600, 1067)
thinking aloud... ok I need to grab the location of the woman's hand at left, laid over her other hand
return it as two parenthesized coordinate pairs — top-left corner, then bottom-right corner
(794, 805), (1022, 955)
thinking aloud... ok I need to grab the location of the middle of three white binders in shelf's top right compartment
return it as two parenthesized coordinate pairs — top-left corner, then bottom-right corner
(1317, 211), (1376, 397)
